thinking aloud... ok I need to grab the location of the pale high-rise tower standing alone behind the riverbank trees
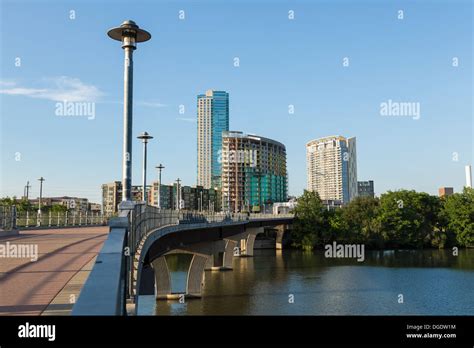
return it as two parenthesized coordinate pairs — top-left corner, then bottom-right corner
(306, 136), (357, 203)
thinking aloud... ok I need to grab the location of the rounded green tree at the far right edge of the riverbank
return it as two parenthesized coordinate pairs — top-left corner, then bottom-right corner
(440, 187), (474, 247)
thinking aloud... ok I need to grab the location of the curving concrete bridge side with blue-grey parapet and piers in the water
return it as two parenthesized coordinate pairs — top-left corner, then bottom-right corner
(72, 203), (293, 315)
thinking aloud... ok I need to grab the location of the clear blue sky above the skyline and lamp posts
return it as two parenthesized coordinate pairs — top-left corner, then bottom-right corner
(0, 0), (474, 202)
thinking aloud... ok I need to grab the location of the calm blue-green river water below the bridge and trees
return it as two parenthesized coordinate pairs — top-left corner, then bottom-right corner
(138, 249), (474, 315)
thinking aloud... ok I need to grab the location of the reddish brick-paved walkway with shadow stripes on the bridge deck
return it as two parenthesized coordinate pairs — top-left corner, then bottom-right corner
(0, 226), (109, 315)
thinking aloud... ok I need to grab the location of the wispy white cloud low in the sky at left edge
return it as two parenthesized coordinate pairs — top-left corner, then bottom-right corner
(0, 76), (104, 102)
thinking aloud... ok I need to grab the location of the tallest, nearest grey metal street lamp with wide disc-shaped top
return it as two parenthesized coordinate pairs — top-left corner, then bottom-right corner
(107, 20), (151, 201)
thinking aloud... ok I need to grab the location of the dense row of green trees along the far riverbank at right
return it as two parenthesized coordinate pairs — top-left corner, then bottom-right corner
(291, 187), (474, 250)
